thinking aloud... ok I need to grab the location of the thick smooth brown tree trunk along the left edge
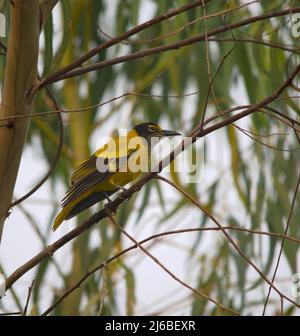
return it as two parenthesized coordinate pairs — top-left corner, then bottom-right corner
(0, 0), (40, 239)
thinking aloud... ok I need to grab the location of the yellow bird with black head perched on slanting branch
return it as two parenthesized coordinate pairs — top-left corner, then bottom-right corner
(53, 122), (180, 231)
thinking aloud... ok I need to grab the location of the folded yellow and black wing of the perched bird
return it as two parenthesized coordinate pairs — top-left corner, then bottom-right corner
(62, 149), (137, 207)
